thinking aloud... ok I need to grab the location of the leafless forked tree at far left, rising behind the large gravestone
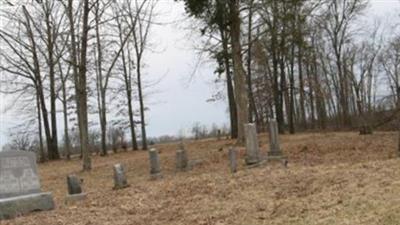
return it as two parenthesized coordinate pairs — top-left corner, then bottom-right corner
(0, 0), (66, 159)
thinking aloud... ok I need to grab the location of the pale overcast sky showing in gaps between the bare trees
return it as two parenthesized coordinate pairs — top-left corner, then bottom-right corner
(0, 0), (400, 148)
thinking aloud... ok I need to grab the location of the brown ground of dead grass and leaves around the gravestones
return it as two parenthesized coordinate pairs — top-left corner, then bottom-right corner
(0, 132), (400, 225)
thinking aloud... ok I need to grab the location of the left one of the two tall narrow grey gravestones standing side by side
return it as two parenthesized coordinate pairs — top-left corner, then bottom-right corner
(244, 123), (260, 165)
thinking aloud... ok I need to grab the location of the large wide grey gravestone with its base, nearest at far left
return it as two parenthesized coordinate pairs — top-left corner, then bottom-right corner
(0, 151), (54, 220)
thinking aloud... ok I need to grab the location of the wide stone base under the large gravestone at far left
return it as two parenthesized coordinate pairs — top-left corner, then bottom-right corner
(0, 192), (54, 220)
